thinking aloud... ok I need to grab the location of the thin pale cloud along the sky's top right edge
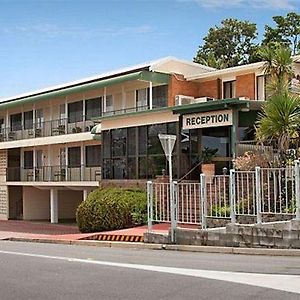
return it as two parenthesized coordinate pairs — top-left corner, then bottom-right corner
(186, 0), (299, 10)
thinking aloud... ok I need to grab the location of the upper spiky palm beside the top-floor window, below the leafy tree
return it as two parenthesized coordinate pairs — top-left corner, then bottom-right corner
(258, 43), (293, 96)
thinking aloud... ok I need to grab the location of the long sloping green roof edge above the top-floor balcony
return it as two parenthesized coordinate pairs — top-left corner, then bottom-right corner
(0, 71), (169, 110)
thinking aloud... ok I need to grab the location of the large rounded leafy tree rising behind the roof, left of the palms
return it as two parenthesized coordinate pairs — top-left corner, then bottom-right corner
(194, 19), (257, 67)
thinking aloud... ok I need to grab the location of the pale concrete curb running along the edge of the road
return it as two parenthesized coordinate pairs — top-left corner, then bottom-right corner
(6, 237), (300, 257)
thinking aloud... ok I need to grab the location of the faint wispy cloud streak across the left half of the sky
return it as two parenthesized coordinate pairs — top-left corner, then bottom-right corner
(0, 23), (152, 38)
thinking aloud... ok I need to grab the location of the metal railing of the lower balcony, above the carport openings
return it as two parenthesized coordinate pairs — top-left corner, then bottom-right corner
(6, 165), (102, 182)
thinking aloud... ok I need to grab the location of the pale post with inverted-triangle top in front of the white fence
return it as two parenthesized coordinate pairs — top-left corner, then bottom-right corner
(158, 134), (176, 243)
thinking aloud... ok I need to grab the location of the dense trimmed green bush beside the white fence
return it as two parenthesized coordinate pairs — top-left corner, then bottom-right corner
(76, 188), (147, 232)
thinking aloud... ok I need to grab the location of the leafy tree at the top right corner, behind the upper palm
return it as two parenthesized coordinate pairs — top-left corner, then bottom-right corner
(262, 12), (300, 55)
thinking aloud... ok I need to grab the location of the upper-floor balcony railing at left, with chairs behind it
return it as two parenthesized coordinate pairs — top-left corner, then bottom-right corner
(0, 118), (94, 142)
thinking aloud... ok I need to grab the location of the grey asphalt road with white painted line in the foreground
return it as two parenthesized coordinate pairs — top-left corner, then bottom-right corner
(0, 241), (300, 300)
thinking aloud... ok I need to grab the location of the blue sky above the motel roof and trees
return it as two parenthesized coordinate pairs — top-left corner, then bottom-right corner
(0, 0), (300, 98)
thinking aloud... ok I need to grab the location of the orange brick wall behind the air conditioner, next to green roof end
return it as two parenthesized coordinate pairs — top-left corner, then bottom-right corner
(168, 74), (199, 106)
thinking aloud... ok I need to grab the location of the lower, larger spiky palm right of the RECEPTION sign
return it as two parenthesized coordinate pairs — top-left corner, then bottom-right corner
(256, 91), (300, 159)
